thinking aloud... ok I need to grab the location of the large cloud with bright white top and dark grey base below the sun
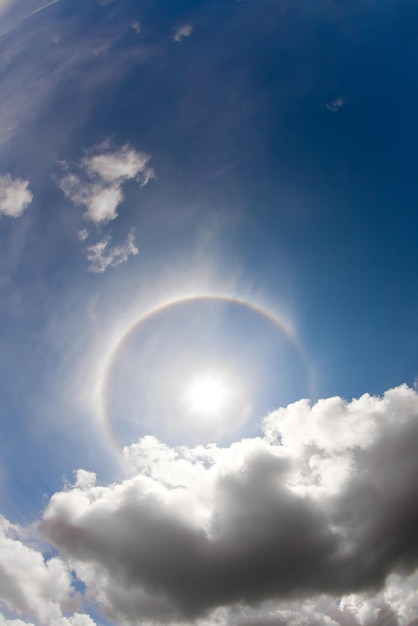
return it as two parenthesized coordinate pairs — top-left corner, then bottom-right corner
(42, 386), (418, 626)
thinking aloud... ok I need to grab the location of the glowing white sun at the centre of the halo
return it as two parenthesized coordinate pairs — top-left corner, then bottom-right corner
(184, 374), (228, 415)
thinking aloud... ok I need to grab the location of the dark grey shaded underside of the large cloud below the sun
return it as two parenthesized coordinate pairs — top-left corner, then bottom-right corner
(43, 394), (418, 620)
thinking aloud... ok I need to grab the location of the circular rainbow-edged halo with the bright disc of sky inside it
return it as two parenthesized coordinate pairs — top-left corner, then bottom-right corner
(100, 295), (311, 450)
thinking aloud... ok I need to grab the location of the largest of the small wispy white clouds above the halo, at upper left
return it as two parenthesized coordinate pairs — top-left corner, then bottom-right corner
(59, 144), (154, 224)
